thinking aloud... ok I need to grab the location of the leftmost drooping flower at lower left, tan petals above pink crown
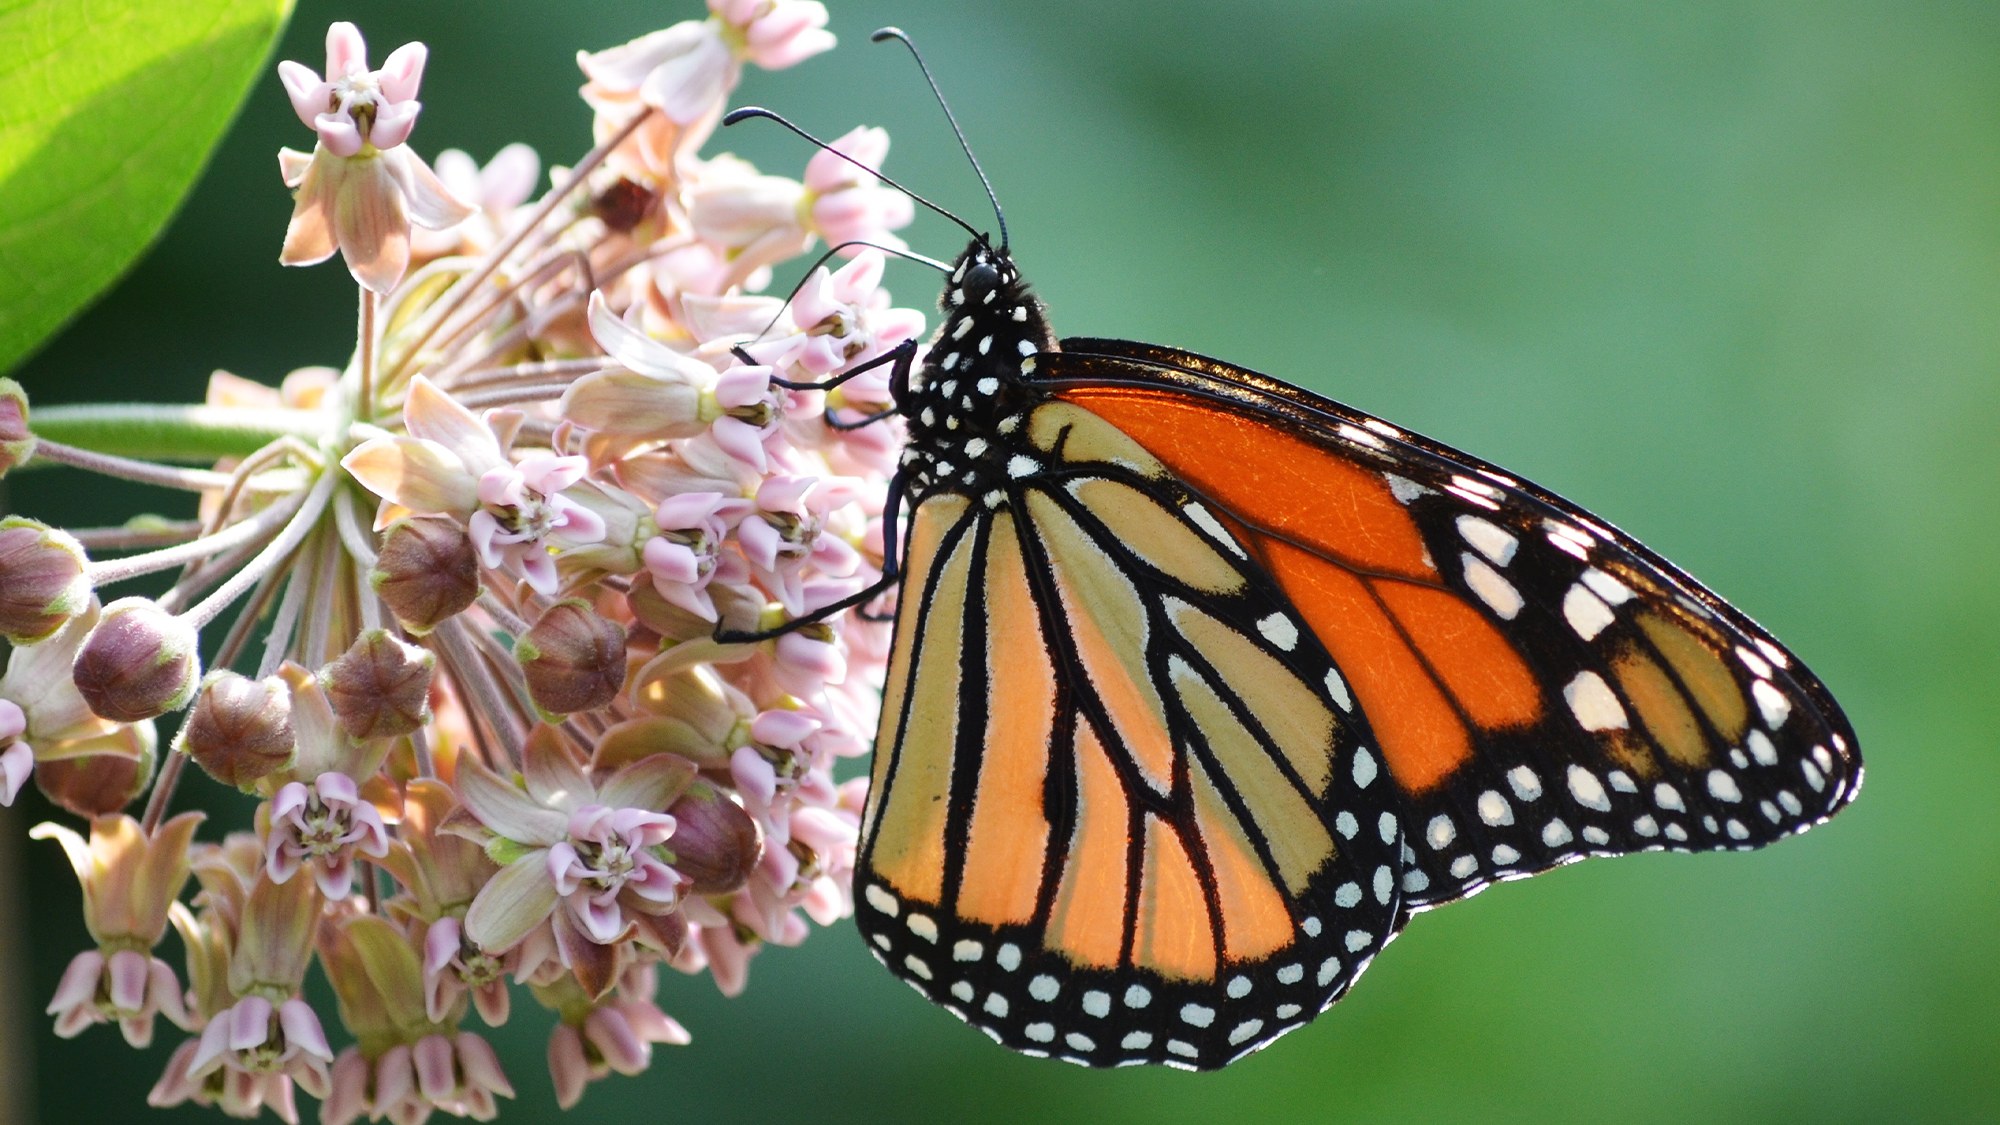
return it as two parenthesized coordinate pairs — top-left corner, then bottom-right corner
(28, 813), (202, 1047)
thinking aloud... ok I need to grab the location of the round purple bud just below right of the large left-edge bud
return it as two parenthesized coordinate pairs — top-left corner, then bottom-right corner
(72, 599), (202, 723)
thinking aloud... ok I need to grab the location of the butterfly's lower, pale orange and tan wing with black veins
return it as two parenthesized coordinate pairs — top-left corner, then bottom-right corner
(856, 404), (1404, 1069)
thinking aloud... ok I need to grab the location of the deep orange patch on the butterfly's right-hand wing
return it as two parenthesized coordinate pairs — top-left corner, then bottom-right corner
(1062, 386), (1544, 793)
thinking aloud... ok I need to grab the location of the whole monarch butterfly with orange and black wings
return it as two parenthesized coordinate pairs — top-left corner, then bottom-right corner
(724, 30), (1862, 1069)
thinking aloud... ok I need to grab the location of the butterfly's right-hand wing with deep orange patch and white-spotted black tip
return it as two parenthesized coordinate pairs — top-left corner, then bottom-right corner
(1040, 340), (1860, 909)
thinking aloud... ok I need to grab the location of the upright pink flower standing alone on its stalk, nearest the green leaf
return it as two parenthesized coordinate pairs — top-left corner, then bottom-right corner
(278, 22), (474, 292)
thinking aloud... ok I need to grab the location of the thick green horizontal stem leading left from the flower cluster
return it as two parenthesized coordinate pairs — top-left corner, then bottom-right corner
(28, 402), (332, 464)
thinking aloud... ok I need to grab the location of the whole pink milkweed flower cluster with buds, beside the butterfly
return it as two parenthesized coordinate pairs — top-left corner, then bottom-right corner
(0, 0), (924, 1125)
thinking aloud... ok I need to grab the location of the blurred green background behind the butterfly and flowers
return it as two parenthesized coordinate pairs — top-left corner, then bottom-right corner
(6, 0), (2000, 1125)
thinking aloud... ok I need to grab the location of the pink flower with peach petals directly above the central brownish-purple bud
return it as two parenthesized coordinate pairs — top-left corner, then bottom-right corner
(340, 374), (606, 595)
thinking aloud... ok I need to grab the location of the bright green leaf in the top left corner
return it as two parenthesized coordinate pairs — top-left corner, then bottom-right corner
(0, 0), (292, 372)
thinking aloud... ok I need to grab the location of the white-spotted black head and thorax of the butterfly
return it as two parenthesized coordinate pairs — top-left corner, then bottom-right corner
(898, 240), (1056, 494)
